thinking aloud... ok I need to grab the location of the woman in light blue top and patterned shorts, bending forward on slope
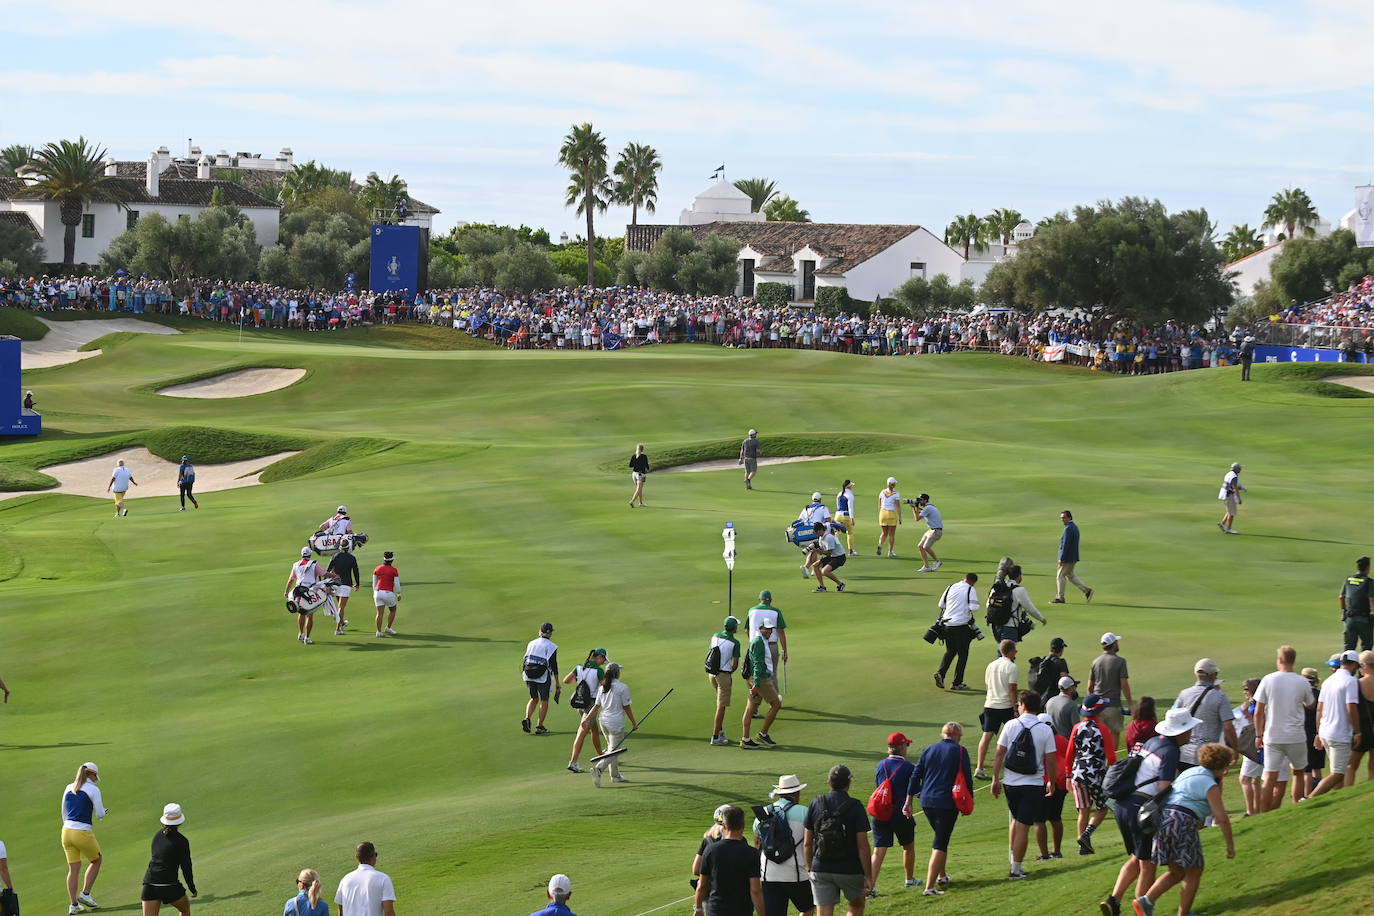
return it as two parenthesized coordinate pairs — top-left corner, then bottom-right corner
(1135, 741), (1235, 916)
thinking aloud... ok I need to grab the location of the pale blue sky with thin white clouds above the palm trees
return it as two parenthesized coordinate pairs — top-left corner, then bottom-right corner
(0, 0), (1374, 236)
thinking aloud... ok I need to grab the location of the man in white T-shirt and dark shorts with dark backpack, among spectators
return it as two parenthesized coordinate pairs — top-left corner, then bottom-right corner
(992, 691), (1058, 880)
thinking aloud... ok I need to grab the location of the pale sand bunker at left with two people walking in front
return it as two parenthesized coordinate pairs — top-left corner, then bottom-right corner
(0, 446), (297, 500)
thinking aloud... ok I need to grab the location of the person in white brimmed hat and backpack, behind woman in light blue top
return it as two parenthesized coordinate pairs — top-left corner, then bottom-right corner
(1099, 709), (1198, 916)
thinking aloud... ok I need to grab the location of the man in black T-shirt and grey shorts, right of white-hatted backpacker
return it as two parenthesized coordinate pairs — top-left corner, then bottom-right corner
(802, 764), (872, 916)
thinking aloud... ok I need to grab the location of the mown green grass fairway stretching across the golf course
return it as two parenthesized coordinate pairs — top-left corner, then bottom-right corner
(0, 321), (1374, 916)
